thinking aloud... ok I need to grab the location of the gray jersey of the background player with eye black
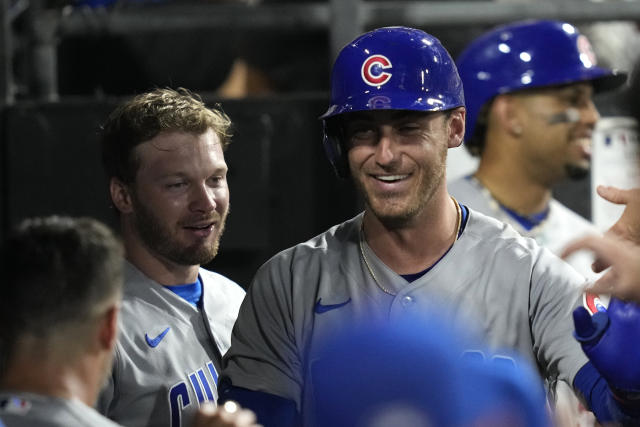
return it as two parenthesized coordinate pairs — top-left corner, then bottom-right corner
(448, 177), (598, 278)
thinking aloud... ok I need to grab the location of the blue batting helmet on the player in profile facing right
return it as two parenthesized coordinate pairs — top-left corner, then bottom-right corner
(457, 20), (626, 150)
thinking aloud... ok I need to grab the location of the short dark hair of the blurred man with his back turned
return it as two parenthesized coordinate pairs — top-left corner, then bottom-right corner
(0, 216), (124, 361)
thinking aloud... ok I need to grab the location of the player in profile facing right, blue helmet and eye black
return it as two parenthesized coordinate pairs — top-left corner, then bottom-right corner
(449, 20), (626, 276)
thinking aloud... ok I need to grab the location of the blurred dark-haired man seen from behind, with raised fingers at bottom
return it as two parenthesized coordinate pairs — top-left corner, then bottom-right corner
(0, 216), (257, 427)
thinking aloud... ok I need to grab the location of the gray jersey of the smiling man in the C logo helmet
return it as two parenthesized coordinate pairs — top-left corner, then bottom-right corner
(223, 210), (587, 426)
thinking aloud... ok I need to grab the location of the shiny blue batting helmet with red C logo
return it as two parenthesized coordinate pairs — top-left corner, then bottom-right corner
(320, 27), (464, 176)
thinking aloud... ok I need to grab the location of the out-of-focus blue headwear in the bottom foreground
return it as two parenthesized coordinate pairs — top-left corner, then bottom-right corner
(312, 310), (551, 427)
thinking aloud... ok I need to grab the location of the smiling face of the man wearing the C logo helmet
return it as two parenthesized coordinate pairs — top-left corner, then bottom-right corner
(344, 110), (449, 224)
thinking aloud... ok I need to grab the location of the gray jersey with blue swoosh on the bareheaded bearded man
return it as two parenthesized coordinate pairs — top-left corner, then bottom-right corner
(98, 263), (244, 427)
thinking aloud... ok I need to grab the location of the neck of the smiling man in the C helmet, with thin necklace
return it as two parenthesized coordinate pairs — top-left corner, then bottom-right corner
(363, 190), (459, 274)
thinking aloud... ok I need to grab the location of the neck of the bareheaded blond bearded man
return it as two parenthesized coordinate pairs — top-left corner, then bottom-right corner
(122, 222), (200, 286)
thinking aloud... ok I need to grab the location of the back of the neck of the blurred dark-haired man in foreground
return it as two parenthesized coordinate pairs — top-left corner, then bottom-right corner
(1, 353), (104, 406)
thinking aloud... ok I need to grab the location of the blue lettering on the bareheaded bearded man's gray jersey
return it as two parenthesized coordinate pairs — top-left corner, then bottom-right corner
(168, 361), (218, 427)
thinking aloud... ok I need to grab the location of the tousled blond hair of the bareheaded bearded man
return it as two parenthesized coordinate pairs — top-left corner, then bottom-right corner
(101, 88), (231, 183)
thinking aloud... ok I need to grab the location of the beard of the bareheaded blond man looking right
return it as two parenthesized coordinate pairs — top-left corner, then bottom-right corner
(133, 195), (229, 266)
